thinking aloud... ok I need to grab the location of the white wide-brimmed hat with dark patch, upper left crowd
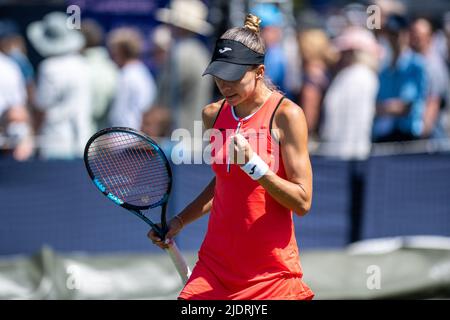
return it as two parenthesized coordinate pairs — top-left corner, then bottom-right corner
(27, 12), (85, 57)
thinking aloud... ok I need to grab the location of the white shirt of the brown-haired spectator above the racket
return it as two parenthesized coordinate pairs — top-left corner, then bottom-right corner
(109, 61), (156, 130)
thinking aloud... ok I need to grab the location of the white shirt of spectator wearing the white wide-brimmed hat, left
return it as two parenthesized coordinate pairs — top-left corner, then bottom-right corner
(36, 54), (93, 159)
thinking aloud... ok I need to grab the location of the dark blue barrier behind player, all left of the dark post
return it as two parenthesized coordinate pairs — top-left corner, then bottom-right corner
(0, 159), (349, 254)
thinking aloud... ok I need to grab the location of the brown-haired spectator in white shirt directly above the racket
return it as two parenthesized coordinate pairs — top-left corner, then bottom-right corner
(107, 28), (156, 130)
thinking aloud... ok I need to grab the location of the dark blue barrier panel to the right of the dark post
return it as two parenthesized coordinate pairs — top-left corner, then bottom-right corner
(362, 154), (450, 239)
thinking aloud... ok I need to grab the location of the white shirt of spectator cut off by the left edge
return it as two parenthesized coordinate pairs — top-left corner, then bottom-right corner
(0, 52), (26, 117)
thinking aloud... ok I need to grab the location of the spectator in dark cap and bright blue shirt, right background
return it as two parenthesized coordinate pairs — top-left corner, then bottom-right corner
(373, 15), (427, 142)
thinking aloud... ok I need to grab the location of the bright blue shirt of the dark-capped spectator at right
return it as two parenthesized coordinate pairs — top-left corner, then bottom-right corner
(373, 49), (428, 138)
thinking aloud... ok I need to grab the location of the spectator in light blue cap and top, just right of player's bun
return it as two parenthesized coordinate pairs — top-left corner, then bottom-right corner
(251, 3), (287, 93)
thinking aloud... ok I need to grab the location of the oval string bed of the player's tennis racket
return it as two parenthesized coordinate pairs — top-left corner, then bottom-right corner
(88, 132), (170, 206)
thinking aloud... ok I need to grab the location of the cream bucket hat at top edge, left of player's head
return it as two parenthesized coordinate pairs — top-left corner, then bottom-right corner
(156, 0), (213, 36)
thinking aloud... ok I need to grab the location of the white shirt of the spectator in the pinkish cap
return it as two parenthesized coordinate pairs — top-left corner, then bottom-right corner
(320, 64), (378, 160)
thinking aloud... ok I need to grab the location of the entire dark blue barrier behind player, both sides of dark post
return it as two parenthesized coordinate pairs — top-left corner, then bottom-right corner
(0, 155), (450, 255)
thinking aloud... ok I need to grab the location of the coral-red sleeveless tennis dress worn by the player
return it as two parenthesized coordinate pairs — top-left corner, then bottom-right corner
(179, 92), (314, 300)
